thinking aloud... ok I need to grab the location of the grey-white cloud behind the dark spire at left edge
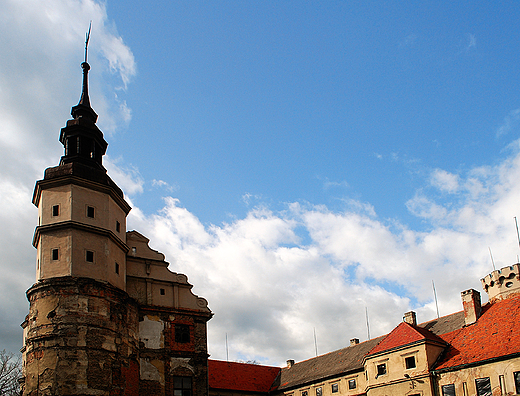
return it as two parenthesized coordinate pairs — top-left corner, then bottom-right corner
(0, 0), (135, 351)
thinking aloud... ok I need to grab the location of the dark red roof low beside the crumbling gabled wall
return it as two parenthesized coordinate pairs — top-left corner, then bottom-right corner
(208, 359), (280, 393)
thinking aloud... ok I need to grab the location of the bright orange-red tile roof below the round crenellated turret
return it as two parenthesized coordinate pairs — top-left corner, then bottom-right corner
(436, 295), (520, 370)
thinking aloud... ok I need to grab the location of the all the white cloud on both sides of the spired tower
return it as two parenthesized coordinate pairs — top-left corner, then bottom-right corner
(4, 0), (520, 372)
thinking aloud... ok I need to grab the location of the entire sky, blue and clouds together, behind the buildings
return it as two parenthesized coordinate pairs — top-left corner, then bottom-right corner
(0, 0), (520, 364)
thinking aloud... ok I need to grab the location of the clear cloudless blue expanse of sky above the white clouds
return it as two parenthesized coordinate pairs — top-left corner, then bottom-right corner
(107, 2), (519, 227)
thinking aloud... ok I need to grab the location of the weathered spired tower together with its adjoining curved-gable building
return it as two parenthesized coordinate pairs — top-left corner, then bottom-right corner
(21, 32), (212, 396)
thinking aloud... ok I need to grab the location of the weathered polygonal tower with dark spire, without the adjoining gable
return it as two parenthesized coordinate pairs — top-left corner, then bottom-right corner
(22, 53), (138, 395)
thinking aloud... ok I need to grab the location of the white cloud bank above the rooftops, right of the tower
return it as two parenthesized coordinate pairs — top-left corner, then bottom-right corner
(124, 142), (520, 364)
